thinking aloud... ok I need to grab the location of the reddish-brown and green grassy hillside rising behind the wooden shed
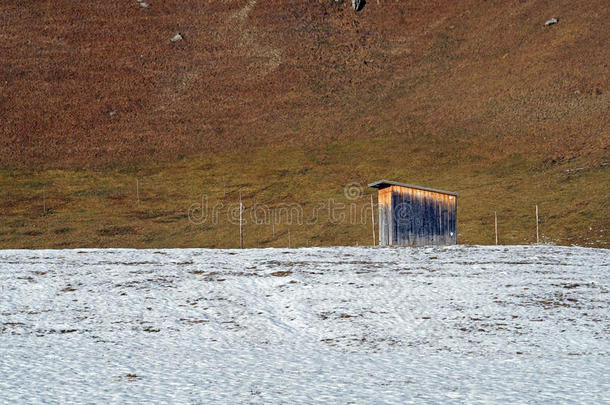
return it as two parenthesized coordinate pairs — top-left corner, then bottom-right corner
(0, 0), (610, 247)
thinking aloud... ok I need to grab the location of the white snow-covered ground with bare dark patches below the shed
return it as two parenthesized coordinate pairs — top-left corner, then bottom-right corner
(0, 246), (610, 404)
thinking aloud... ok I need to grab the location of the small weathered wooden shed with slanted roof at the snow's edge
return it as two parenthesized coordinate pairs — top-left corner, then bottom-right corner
(369, 180), (458, 246)
